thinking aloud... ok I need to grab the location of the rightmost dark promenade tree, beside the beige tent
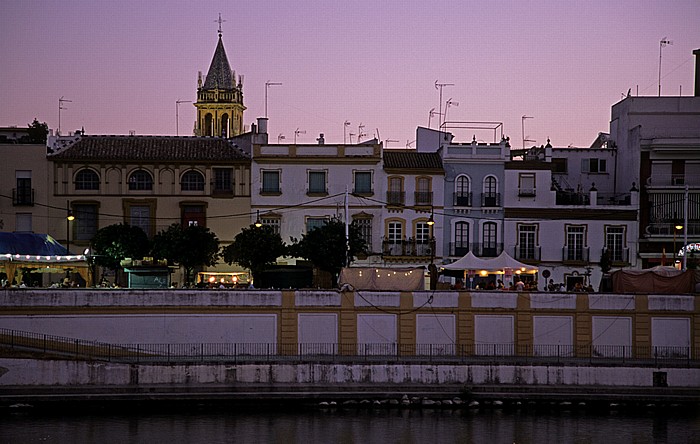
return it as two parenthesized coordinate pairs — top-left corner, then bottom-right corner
(290, 218), (367, 279)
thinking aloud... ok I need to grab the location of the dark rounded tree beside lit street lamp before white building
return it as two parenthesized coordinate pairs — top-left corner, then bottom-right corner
(223, 225), (287, 280)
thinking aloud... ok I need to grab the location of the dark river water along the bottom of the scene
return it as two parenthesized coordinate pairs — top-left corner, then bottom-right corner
(0, 406), (700, 444)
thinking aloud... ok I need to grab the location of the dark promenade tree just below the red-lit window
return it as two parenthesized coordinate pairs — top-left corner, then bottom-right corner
(151, 223), (219, 284)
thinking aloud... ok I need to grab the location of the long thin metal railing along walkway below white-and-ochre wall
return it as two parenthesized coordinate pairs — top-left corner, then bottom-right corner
(0, 329), (700, 367)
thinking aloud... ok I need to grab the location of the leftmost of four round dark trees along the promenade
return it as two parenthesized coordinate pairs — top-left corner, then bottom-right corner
(91, 224), (150, 271)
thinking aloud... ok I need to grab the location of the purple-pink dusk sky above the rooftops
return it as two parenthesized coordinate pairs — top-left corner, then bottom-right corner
(0, 0), (700, 148)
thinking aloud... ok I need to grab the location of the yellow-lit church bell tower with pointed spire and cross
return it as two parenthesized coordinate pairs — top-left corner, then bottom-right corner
(194, 14), (245, 137)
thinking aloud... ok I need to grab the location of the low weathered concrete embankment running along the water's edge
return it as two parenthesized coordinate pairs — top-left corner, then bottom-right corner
(0, 359), (700, 406)
